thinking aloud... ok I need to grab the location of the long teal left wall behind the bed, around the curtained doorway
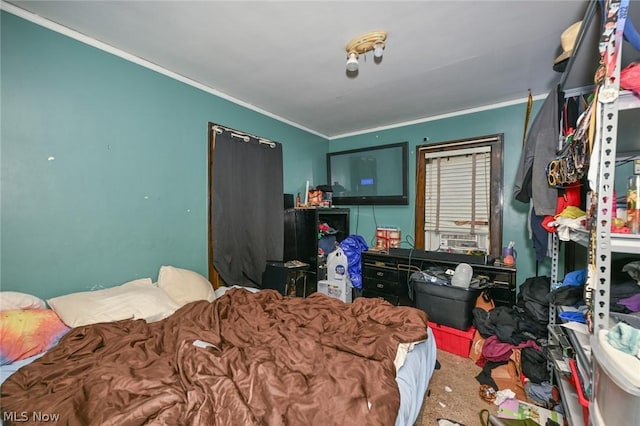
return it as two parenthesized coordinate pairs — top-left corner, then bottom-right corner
(0, 11), (327, 298)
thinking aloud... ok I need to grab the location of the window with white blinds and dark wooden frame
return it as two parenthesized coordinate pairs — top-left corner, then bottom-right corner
(415, 135), (503, 257)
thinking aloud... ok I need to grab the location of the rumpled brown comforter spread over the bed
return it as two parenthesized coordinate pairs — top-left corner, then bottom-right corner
(0, 289), (427, 426)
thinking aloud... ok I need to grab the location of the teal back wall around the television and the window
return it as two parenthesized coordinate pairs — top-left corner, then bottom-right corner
(329, 101), (550, 283)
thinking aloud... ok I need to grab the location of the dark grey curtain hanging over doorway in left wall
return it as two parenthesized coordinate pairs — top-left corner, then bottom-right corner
(209, 125), (284, 287)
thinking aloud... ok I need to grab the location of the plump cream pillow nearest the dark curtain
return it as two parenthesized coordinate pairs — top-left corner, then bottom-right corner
(158, 266), (216, 306)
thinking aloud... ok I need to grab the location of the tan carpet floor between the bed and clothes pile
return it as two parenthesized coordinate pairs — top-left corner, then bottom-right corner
(415, 350), (498, 426)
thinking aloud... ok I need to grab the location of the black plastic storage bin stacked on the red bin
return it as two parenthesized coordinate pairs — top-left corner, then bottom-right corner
(410, 271), (481, 330)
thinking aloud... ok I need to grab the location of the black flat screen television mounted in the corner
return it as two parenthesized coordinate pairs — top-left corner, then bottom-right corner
(327, 142), (409, 205)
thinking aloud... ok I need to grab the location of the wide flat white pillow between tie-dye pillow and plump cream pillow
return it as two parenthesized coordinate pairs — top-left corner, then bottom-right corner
(47, 278), (179, 327)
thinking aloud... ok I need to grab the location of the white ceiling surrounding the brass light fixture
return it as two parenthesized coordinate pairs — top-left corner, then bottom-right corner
(3, 0), (587, 139)
